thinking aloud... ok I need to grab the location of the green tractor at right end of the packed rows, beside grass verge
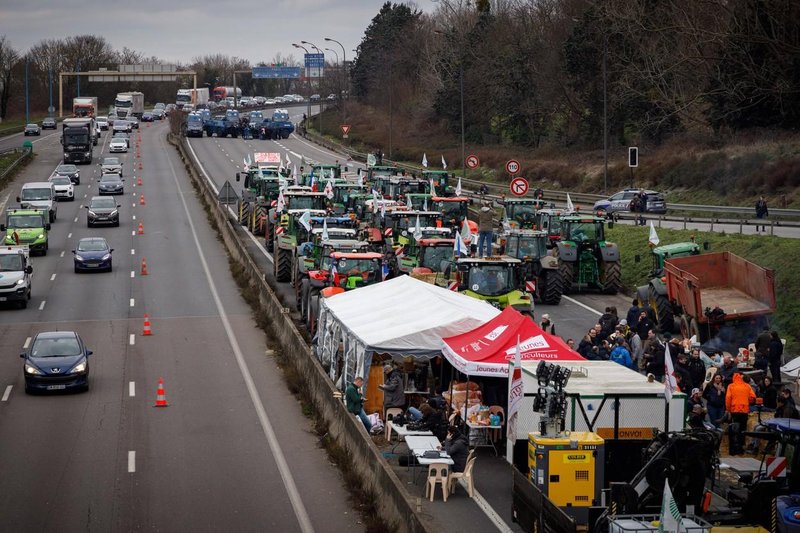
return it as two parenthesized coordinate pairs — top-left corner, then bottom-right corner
(556, 214), (622, 294)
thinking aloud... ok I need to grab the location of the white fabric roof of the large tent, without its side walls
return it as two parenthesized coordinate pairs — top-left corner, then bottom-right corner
(323, 276), (500, 357)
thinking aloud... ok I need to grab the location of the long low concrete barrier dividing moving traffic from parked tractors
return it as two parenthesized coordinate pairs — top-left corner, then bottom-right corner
(170, 137), (433, 533)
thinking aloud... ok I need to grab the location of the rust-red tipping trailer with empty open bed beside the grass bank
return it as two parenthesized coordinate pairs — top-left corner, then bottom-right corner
(664, 252), (776, 353)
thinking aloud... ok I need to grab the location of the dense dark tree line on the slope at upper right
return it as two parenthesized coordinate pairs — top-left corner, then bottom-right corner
(351, 0), (800, 147)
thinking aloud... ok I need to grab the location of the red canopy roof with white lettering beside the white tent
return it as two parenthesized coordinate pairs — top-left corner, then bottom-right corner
(442, 307), (584, 377)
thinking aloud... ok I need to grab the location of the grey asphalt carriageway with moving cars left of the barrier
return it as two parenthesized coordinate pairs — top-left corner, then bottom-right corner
(0, 123), (363, 531)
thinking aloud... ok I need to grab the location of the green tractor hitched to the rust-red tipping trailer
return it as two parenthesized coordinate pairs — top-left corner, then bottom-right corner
(634, 241), (708, 331)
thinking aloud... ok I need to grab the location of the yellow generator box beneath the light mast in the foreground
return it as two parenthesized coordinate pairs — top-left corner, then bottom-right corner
(528, 431), (605, 524)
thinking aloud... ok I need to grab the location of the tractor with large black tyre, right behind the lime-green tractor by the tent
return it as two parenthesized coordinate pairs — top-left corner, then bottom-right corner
(500, 229), (564, 305)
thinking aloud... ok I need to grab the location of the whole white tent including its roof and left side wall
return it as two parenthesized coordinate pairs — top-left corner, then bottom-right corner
(315, 276), (500, 383)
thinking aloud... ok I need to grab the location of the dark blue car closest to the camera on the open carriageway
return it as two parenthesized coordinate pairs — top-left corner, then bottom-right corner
(20, 331), (92, 394)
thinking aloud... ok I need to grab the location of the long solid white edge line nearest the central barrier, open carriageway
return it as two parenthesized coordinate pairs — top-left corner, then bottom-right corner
(161, 139), (314, 533)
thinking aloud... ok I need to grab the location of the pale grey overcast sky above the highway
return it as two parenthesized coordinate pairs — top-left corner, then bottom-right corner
(0, 0), (436, 64)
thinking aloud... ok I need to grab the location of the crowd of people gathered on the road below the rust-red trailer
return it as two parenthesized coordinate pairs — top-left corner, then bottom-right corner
(567, 299), (800, 453)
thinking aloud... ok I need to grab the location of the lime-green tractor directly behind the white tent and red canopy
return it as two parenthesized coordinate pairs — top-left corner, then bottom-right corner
(436, 257), (534, 319)
